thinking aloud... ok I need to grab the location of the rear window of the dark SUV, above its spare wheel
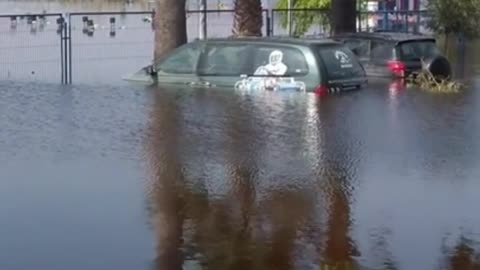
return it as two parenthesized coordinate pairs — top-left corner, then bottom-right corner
(398, 40), (440, 61)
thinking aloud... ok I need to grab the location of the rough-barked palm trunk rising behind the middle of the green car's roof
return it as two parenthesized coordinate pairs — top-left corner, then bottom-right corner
(232, 0), (263, 36)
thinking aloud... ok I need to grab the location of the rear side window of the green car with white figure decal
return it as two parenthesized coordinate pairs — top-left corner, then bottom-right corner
(250, 45), (308, 77)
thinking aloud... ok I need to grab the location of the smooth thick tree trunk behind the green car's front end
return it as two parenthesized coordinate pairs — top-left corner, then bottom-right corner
(154, 0), (187, 62)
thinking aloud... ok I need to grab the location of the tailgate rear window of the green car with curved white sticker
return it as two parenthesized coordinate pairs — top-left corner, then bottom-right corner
(317, 45), (365, 80)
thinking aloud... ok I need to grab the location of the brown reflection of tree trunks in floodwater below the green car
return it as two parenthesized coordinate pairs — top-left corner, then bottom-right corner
(142, 89), (368, 269)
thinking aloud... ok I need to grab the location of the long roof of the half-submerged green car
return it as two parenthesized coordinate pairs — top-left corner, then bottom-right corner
(192, 36), (341, 46)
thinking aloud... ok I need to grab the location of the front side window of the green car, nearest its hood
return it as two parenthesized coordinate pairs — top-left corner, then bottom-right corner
(157, 43), (201, 74)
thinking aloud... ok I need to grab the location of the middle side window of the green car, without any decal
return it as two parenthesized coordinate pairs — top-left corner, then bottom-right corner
(199, 43), (250, 76)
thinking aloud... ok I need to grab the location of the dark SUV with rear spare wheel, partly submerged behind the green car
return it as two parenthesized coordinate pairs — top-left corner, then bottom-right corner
(331, 32), (451, 78)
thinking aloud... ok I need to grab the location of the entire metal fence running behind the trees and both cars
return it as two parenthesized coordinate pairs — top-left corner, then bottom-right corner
(0, 9), (434, 84)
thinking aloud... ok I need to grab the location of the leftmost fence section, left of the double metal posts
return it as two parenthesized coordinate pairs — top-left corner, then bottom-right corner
(0, 14), (64, 82)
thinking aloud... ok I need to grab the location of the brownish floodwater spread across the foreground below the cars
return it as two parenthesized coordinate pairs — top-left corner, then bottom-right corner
(0, 78), (480, 270)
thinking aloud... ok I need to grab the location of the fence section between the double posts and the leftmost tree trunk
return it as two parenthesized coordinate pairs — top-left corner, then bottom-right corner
(68, 12), (154, 83)
